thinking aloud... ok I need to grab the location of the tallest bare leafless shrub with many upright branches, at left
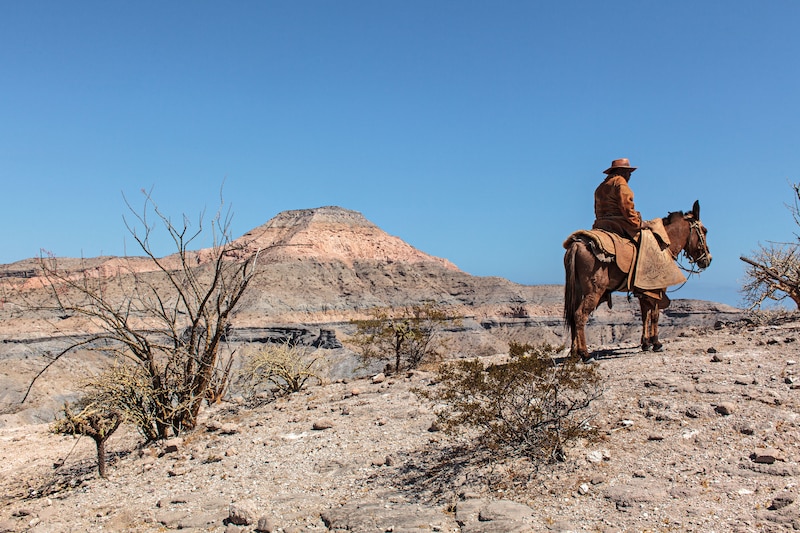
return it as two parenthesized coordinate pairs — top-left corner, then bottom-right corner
(23, 191), (258, 439)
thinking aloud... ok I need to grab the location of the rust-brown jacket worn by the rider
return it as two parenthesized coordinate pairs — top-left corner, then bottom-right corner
(592, 174), (642, 239)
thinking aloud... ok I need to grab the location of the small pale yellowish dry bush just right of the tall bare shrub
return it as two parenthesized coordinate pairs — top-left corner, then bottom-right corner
(237, 342), (321, 398)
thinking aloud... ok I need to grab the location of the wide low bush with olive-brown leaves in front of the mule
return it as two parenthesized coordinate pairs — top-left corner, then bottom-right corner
(417, 342), (602, 464)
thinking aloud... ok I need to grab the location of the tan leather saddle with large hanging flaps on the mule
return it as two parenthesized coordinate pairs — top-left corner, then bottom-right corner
(564, 218), (686, 303)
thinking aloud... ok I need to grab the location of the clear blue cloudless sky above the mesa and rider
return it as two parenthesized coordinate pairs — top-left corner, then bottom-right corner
(0, 0), (800, 304)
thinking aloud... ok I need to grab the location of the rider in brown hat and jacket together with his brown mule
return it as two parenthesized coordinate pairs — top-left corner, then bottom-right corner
(564, 158), (711, 361)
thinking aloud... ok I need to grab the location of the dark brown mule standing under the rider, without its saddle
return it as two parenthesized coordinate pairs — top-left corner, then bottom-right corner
(564, 201), (711, 361)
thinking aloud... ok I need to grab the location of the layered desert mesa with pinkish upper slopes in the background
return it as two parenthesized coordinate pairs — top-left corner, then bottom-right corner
(0, 207), (738, 424)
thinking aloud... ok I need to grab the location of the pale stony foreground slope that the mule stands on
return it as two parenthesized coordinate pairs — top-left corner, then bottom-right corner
(0, 317), (800, 533)
